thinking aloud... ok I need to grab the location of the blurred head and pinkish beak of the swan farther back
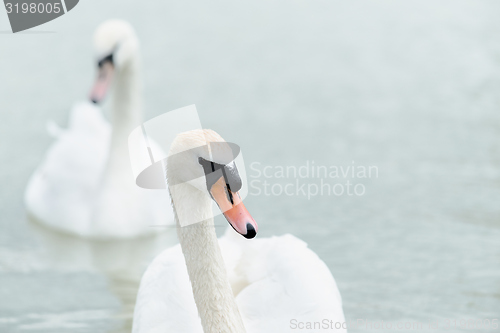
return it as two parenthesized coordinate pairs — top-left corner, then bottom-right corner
(90, 20), (139, 103)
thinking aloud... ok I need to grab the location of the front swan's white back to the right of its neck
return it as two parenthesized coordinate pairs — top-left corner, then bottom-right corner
(225, 234), (345, 332)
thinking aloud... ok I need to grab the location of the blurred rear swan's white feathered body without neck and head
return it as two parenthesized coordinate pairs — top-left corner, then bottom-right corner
(25, 102), (173, 238)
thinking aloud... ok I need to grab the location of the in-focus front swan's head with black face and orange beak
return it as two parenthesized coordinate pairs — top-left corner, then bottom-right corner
(167, 130), (258, 238)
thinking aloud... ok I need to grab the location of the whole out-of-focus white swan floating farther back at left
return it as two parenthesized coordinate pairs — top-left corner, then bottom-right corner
(25, 20), (173, 238)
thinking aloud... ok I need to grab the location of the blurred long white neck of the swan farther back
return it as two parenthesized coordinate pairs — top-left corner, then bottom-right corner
(104, 58), (142, 182)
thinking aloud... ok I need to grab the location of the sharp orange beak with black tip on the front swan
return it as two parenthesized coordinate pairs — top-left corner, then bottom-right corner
(210, 177), (258, 238)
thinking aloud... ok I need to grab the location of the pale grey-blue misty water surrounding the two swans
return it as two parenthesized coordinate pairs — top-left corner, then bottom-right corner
(0, 0), (500, 333)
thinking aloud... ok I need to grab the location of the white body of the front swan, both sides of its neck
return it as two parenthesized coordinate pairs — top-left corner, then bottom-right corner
(133, 230), (344, 333)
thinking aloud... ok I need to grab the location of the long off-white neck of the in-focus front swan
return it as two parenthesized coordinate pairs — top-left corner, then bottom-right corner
(170, 179), (245, 333)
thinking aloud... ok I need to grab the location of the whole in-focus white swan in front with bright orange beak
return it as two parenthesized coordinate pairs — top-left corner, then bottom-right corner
(133, 130), (346, 333)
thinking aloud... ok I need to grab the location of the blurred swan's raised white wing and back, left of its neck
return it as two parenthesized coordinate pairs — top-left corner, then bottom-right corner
(25, 103), (111, 234)
